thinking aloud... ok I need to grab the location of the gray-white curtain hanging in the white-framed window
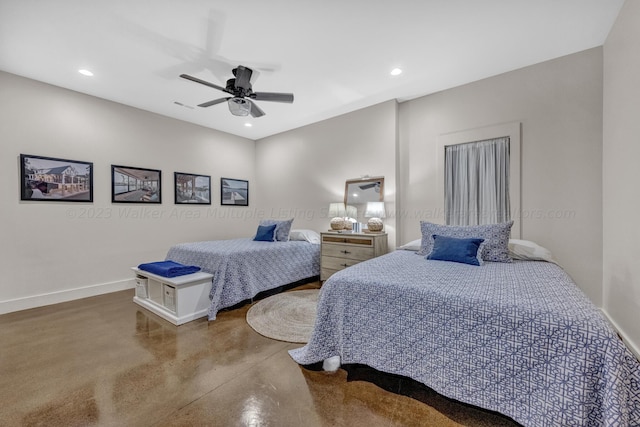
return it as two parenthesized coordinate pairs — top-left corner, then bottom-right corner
(445, 137), (510, 225)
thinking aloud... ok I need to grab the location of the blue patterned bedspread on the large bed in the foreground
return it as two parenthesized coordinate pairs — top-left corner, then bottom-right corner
(290, 251), (640, 427)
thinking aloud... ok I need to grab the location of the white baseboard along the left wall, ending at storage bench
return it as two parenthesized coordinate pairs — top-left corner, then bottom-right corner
(0, 279), (136, 314)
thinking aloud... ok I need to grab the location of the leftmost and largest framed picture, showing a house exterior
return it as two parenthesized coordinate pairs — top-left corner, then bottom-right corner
(20, 154), (93, 202)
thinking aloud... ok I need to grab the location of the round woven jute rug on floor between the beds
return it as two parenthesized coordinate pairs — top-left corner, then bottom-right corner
(247, 289), (320, 344)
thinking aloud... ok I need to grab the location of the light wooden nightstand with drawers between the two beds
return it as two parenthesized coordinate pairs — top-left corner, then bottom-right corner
(320, 232), (387, 281)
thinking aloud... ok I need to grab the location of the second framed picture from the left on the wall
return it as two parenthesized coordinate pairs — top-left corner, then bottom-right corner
(111, 165), (162, 203)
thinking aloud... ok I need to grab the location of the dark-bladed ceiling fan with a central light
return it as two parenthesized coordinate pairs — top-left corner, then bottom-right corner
(180, 65), (293, 117)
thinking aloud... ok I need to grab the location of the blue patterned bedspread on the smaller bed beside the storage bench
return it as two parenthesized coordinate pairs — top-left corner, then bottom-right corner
(166, 238), (320, 320)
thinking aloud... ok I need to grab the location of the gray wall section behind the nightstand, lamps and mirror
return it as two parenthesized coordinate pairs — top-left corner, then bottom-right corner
(256, 101), (397, 247)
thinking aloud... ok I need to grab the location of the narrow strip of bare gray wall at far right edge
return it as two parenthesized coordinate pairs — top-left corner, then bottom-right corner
(603, 0), (640, 355)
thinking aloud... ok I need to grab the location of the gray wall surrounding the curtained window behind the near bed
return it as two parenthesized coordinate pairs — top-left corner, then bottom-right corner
(399, 48), (602, 306)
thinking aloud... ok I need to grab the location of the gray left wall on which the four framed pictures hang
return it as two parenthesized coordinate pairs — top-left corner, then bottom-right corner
(0, 72), (257, 313)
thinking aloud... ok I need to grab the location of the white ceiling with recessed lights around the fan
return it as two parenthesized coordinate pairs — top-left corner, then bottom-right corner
(0, 0), (624, 139)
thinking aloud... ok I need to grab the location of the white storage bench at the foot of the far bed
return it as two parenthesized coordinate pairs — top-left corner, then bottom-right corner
(132, 267), (213, 325)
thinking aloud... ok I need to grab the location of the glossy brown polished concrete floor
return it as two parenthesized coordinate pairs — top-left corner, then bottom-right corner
(0, 283), (517, 427)
